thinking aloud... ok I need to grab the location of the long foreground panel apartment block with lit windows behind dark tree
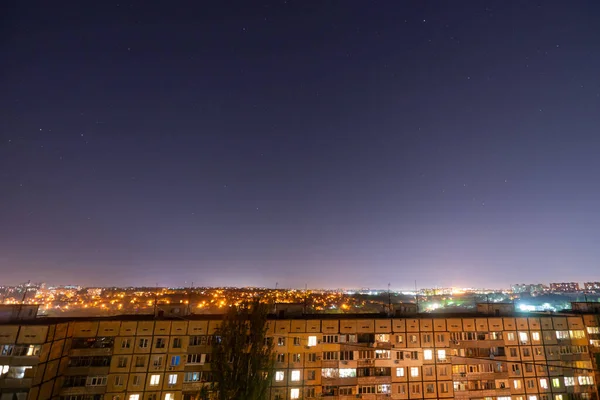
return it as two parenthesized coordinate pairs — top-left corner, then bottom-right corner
(0, 307), (598, 400)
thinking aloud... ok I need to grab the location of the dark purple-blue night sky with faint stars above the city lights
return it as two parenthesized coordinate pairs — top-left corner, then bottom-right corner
(0, 0), (600, 288)
